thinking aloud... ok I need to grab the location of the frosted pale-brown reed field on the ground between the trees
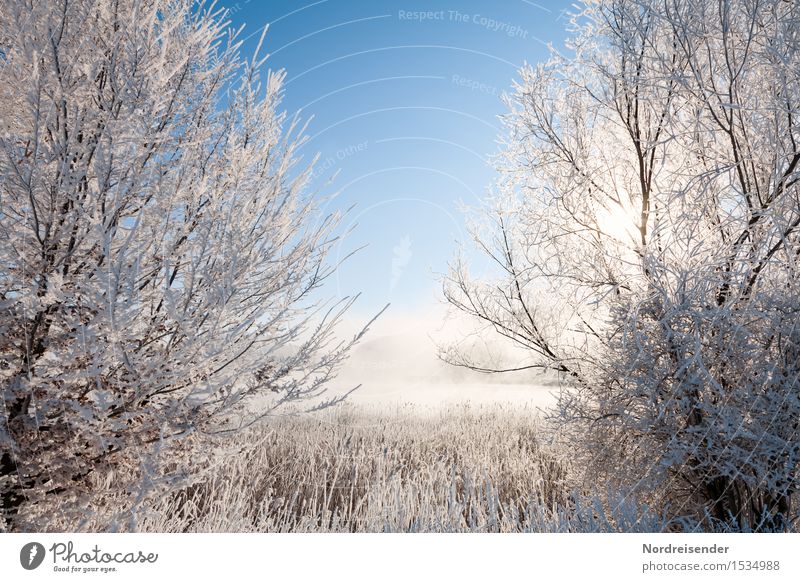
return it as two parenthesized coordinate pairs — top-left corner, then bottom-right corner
(130, 404), (665, 532)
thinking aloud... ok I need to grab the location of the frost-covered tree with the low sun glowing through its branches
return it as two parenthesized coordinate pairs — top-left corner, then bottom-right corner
(445, 0), (800, 530)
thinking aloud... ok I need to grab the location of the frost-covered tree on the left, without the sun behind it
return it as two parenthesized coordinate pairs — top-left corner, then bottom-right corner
(0, 0), (366, 529)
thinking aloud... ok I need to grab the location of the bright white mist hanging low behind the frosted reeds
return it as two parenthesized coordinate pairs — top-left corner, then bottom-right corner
(329, 309), (558, 408)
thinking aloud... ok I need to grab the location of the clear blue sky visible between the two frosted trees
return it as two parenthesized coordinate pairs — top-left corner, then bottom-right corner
(223, 0), (571, 316)
